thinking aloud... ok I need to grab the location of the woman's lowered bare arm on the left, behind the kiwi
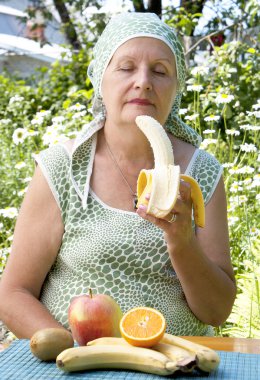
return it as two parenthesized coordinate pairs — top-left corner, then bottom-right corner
(0, 167), (64, 338)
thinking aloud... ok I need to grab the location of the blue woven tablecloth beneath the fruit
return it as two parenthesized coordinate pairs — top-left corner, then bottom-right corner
(0, 339), (260, 380)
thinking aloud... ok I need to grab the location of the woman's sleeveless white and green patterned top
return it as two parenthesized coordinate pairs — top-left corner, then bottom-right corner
(36, 133), (222, 335)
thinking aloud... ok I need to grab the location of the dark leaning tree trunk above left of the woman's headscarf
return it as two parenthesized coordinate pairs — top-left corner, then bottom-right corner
(53, 0), (81, 49)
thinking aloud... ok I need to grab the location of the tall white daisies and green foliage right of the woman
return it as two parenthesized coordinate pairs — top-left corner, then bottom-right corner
(181, 41), (260, 338)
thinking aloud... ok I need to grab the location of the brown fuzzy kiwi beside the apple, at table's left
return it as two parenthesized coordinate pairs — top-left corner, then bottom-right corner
(30, 328), (74, 361)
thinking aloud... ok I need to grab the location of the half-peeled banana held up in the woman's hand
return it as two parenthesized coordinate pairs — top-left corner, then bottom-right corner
(136, 115), (205, 227)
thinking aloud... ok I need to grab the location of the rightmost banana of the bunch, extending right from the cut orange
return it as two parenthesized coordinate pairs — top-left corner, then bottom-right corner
(161, 333), (220, 372)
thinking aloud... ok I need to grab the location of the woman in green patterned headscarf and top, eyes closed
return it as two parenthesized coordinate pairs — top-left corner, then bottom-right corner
(0, 13), (236, 338)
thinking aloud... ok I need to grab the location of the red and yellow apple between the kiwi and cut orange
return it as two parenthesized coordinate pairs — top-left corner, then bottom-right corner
(68, 289), (123, 346)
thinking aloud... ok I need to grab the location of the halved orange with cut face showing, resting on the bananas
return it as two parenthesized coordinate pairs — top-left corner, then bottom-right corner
(120, 307), (166, 347)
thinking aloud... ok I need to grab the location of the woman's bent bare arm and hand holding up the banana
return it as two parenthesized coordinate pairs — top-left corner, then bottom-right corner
(138, 179), (236, 326)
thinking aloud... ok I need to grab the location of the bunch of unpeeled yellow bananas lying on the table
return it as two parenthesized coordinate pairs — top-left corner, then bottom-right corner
(56, 334), (220, 376)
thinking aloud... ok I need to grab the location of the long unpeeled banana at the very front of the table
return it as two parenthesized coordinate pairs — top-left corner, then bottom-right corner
(56, 345), (179, 376)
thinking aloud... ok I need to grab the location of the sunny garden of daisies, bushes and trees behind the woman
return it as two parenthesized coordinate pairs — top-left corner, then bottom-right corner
(0, 0), (260, 338)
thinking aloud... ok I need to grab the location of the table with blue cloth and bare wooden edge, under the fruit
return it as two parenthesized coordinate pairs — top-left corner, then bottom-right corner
(0, 337), (260, 380)
